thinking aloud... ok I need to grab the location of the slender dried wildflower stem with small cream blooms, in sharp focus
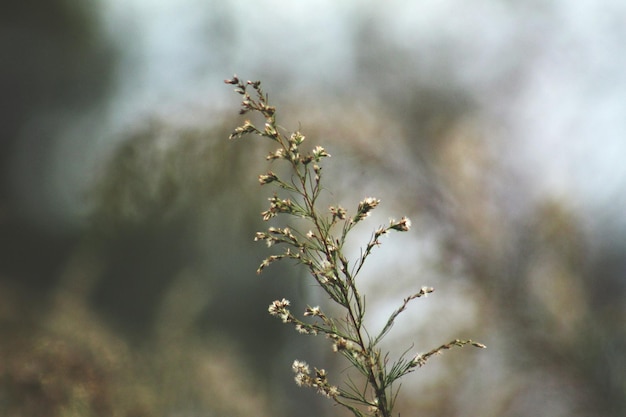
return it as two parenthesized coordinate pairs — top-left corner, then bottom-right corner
(225, 76), (485, 417)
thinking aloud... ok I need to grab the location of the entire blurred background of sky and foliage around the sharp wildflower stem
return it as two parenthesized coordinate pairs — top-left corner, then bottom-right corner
(0, 0), (626, 417)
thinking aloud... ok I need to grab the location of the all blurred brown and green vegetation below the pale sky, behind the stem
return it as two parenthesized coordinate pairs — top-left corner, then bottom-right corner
(0, 1), (626, 417)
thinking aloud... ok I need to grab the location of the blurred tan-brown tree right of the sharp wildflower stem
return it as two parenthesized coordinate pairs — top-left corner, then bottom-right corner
(292, 75), (626, 417)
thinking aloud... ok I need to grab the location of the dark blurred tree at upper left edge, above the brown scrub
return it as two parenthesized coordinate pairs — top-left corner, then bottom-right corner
(0, 0), (115, 288)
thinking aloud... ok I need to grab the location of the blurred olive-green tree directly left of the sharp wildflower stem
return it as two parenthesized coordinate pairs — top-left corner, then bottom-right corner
(84, 122), (332, 415)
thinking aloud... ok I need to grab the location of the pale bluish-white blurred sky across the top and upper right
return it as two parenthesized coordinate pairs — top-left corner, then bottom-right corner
(35, 0), (626, 234)
